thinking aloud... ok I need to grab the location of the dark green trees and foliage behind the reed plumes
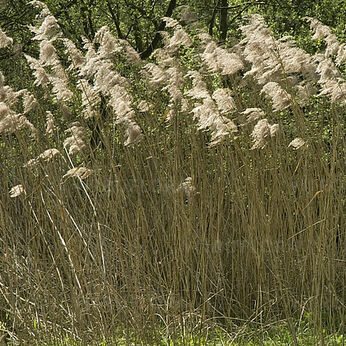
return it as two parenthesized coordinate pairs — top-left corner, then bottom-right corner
(0, 0), (346, 57)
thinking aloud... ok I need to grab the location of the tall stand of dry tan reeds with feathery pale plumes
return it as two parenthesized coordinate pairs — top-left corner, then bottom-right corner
(0, 1), (346, 344)
